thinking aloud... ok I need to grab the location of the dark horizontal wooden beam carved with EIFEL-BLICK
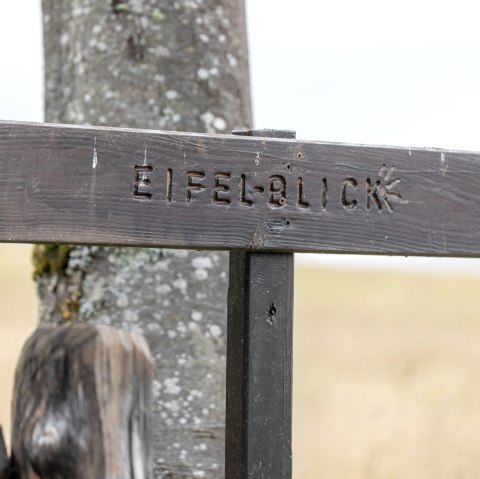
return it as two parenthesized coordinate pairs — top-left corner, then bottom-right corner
(0, 122), (480, 256)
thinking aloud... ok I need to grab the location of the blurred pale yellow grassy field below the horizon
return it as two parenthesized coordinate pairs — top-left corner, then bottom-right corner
(0, 245), (480, 479)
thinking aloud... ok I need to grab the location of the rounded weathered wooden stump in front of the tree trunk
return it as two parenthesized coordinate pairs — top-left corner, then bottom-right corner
(12, 324), (153, 479)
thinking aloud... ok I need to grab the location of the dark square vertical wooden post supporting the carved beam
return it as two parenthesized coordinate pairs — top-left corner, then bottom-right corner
(225, 130), (295, 479)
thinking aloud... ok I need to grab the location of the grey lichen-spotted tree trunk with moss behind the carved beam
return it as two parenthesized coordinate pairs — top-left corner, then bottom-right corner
(39, 0), (251, 478)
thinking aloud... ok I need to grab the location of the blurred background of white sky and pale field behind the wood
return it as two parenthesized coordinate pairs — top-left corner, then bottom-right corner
(0, 0), (480, 479)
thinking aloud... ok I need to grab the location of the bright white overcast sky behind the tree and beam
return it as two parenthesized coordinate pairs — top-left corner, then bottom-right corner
(0, 0), (480, 272)
